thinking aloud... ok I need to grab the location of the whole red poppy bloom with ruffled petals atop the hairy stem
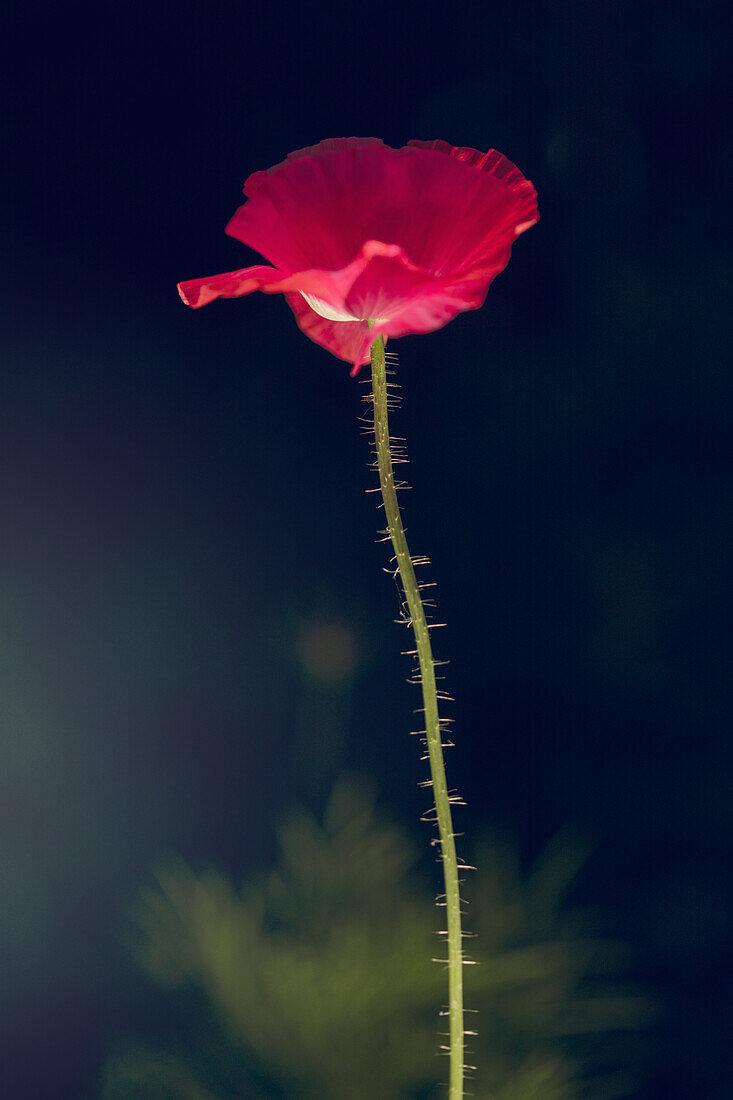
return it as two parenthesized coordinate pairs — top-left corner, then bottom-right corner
(178, 138), (538, 374)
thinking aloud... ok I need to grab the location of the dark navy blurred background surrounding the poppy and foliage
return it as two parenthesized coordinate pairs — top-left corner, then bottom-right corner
(0, 0), (733, 1100)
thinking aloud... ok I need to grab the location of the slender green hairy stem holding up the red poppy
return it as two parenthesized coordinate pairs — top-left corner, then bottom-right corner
(371, 327), (463, 1100)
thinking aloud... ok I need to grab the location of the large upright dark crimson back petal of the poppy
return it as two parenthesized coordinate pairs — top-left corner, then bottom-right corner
(227, 138), (538, 275)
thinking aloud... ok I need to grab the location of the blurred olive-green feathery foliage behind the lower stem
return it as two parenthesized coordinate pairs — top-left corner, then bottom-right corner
(101, 778), (649, 1100)
